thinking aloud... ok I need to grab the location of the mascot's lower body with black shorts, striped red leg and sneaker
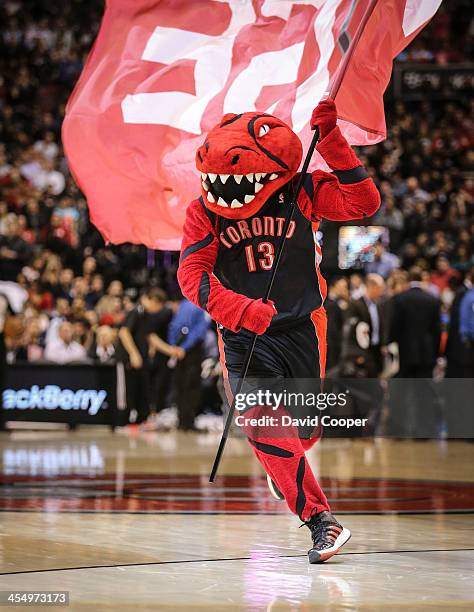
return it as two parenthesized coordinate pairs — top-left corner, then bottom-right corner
(219, 320), (351, 563)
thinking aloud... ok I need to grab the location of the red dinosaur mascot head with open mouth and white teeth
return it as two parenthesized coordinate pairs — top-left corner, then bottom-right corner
(196, 113), (303, 219)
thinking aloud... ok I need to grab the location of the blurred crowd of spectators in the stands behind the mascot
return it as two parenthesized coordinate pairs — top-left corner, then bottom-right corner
(0, 0), (474, 430)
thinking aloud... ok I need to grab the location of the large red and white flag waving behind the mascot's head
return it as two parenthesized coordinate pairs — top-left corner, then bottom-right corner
(63, 0), (441, 249)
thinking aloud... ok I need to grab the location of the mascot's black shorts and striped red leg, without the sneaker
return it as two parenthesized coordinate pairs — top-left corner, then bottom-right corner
(218, 320), (329, 520)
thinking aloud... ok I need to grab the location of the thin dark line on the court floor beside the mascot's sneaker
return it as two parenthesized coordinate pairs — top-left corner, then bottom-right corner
(0, 548), (474, 576)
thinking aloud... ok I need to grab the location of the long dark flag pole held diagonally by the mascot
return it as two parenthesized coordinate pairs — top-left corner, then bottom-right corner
(209, 0), (377, 482)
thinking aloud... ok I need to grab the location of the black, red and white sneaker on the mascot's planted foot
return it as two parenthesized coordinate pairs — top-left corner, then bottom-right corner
(304, 511), (351, 563)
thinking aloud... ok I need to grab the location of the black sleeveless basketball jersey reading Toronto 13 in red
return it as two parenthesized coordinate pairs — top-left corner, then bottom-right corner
(206, 175), (323, 328)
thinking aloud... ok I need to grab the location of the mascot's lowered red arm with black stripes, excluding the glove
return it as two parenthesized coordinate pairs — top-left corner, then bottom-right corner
(178, 200), (254, 331)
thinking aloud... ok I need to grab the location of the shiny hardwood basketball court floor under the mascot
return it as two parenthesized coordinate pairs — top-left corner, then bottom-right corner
(0, 427), (474, 611)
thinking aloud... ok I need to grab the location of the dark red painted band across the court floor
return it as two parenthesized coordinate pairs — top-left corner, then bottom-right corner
(0, 474), (474, 514)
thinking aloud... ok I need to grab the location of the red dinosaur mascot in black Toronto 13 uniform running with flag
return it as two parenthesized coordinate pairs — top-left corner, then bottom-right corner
(178, 99), (380, 563)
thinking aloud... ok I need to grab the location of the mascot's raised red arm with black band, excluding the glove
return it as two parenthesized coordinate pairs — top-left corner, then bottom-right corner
(310, 127), (380, 221)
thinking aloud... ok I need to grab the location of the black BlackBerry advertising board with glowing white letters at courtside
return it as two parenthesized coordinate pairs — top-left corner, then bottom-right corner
(2, 364), (117, 425)
